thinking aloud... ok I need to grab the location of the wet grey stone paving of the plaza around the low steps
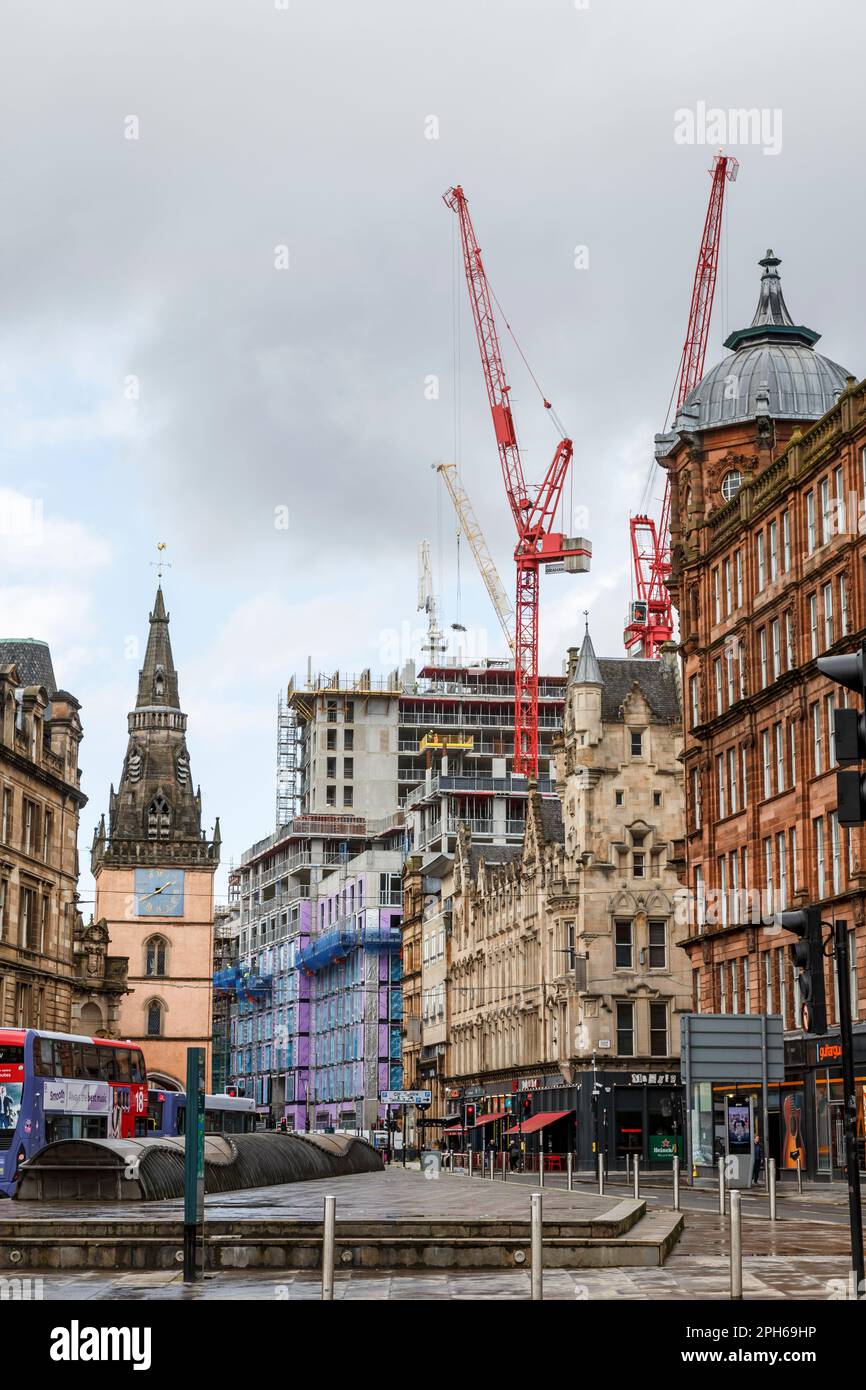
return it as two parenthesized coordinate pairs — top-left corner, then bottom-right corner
(3, 1170), (848, 1301)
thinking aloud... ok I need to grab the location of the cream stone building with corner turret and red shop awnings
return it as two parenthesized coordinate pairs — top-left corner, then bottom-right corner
(446, 632), (691, 1163)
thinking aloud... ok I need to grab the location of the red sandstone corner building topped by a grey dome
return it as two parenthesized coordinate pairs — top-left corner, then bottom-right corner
(656, 252), (866, 1176)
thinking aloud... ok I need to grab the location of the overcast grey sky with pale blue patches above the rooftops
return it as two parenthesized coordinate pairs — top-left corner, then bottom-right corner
(0, 0), (866, 910)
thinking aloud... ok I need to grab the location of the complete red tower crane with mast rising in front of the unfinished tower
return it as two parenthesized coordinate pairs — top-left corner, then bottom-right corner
(445, 186), (592, 777)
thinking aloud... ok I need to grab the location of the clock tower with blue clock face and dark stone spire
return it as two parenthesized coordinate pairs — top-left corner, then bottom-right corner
(92, 584), (220, 1090)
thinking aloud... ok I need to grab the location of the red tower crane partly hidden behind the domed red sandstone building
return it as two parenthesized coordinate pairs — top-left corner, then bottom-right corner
(623, 154), (740, 656)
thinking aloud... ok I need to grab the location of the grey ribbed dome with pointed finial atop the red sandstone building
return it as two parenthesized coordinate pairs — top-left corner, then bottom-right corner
(681, 250), (849, 430)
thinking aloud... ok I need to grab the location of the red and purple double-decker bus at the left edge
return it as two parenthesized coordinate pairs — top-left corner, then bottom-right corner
(0, 1029), (147, 1197)
